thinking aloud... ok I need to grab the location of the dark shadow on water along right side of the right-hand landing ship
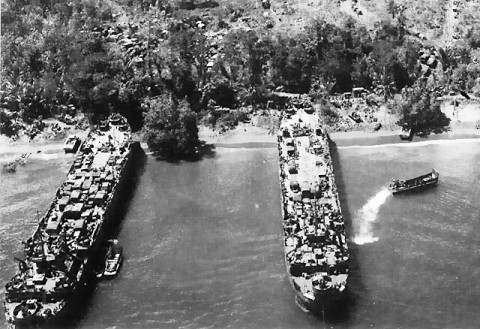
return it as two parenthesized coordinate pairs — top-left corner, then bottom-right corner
(315, 141), (364, 324)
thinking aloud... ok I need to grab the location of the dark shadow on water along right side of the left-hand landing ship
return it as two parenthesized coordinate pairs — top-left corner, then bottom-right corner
(44, 144), (147, 329)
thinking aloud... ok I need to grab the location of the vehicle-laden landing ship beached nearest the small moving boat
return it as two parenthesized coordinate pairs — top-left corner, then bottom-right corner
(278, 110), (349, 312)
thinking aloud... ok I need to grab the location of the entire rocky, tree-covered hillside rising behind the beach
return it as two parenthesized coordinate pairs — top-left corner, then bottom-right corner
(0, 0), (480, 135)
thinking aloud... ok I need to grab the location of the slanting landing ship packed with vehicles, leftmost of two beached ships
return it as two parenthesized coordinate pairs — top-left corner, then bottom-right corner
(5, 115), (136, 325)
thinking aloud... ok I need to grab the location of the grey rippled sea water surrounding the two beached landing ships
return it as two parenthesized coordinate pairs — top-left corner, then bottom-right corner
(0, 138), (480, 329)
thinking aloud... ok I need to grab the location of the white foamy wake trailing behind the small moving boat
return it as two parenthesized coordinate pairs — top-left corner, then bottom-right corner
(353, 188), (391, 245)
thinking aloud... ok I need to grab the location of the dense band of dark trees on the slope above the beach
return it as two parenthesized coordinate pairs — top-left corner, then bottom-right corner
(0, 0), (476, 152)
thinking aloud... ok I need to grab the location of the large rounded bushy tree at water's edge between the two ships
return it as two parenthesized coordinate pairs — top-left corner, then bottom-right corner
(143, 94), (199, 158)
